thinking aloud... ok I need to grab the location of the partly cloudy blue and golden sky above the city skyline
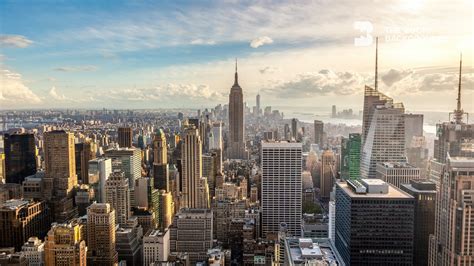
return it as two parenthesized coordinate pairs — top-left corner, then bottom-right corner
(0, 0), (474, 113)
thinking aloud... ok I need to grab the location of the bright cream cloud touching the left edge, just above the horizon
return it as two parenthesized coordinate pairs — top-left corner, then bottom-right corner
(0, 69), (41, 107)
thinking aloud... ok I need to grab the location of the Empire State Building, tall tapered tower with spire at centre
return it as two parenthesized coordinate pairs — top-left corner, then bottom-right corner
(227, 61), (247, 159)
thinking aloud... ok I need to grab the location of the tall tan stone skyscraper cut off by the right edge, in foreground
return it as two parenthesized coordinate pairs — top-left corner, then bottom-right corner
(429, 153), (474, 266)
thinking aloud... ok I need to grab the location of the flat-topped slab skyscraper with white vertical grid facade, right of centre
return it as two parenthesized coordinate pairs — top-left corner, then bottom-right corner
(261, 142), (303, 236)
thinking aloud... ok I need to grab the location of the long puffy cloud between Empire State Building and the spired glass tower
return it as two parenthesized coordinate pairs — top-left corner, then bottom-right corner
(264, 69), (370, 98)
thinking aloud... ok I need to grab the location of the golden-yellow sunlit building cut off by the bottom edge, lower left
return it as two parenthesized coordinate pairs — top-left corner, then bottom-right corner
(44, 221), (87, 266)
